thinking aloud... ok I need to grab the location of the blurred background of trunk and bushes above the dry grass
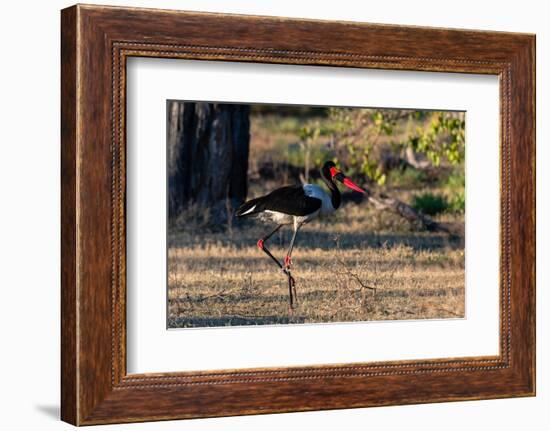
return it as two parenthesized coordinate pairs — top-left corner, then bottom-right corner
(168, 101), (465, 227)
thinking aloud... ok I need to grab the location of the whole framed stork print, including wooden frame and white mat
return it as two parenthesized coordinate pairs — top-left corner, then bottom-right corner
(61, 5), (535, 425)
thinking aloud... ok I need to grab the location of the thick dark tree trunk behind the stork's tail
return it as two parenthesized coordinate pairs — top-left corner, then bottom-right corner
(168, 101), (250, 223)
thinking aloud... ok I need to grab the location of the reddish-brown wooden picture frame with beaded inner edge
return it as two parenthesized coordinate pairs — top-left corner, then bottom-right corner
(61, 5), (535, 425)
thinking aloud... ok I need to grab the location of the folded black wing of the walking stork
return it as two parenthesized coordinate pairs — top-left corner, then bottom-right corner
(236, 185), (322, 217)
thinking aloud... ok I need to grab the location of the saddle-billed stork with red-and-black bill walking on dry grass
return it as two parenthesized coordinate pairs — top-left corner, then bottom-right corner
(235, 160), (367, 310)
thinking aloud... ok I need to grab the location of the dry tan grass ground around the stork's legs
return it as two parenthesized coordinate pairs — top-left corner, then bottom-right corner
(168, 204), (464, 327)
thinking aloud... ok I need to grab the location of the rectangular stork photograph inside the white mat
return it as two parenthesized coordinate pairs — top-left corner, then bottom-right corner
(166, 100), (466, 329)
